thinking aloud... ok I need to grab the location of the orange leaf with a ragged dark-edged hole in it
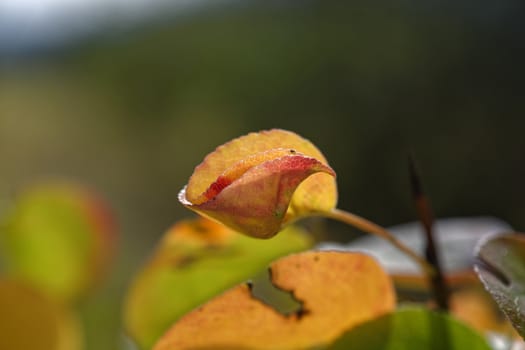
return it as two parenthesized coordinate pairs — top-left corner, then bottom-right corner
(154, 251), (395, 350)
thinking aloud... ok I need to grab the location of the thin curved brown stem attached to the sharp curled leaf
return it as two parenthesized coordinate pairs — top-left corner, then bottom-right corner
(319, 209), (435, 276)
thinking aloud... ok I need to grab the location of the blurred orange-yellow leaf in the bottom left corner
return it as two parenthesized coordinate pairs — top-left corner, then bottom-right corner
(0, 280), (82, 350)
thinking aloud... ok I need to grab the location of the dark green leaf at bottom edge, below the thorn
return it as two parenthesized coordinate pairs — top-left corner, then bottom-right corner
(327, 307), (490, 350)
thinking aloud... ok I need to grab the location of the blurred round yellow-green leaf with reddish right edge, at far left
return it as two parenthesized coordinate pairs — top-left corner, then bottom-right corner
(0, 183), (116, 301)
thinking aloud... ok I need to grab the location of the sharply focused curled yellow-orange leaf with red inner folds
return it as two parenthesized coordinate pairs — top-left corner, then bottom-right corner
(179, 129), (337, 238)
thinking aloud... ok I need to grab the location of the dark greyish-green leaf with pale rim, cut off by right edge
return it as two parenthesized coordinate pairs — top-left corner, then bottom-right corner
(475, 234), (525, 338)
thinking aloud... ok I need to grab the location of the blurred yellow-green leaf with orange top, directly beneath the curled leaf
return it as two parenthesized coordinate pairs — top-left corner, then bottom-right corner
(124, 218), (312, 349)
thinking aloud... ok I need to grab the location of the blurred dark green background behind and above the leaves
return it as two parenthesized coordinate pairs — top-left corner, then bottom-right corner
(0, 0), (525, 349)
